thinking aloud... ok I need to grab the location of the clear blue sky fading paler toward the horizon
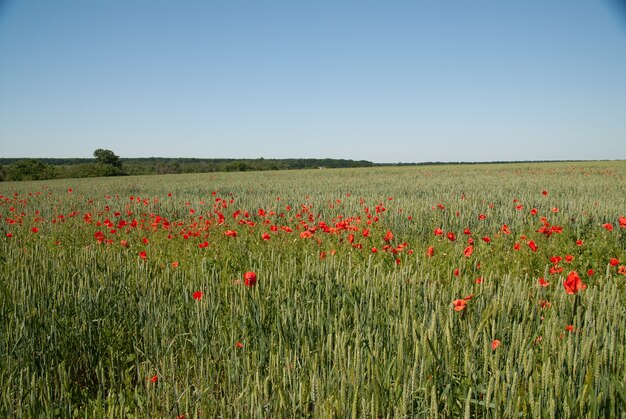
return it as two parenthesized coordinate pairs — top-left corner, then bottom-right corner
(0, 0), (626, 163)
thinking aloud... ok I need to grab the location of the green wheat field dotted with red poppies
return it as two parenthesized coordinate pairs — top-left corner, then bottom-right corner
(0, 162), (626, 418)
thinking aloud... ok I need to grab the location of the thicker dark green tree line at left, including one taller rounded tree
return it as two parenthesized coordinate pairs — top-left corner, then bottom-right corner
(0, 149), (375, 181)
